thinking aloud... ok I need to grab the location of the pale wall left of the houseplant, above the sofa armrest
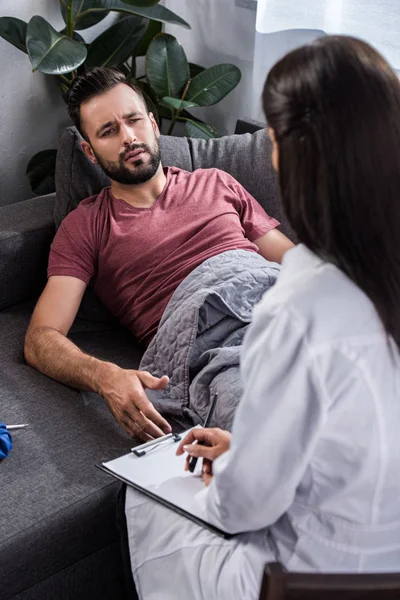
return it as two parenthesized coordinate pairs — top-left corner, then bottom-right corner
(0, 0), (115, 206)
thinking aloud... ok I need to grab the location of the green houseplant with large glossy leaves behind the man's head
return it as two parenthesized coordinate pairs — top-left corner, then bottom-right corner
(0, 0), (241, 194)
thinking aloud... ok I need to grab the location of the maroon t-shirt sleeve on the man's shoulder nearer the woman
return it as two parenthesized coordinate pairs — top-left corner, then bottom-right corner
(227, 175), (280, 242)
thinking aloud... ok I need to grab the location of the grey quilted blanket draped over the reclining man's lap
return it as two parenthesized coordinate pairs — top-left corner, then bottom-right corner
(140, 250), (279, 430)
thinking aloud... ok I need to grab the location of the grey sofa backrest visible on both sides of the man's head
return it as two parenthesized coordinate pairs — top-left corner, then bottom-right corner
(54, 127), (291, 236)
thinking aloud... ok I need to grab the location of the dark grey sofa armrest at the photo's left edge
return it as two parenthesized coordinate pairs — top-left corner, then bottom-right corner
(0, 194), (55, 310)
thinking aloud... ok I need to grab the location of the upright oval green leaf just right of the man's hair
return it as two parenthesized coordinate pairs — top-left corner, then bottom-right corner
(145, 33), (190, 98)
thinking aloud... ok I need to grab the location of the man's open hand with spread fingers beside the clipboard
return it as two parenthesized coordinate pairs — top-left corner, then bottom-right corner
(99, 364), (171, 441)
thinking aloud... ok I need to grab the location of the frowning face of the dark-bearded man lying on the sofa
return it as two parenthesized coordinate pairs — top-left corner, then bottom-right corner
(81, 83), (160, 185)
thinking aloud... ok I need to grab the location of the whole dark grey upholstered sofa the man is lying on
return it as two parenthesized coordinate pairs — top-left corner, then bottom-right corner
(0, 125), (288, 600)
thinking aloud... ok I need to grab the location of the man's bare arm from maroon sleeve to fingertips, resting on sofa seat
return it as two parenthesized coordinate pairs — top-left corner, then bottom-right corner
(24, 276), (171, 440)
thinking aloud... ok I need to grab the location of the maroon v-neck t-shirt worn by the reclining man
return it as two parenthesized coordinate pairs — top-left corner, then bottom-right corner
(48, 167), (279, 343)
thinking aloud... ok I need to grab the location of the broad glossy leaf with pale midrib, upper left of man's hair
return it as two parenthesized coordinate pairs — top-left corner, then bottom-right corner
(26, 17), (87, 75)
